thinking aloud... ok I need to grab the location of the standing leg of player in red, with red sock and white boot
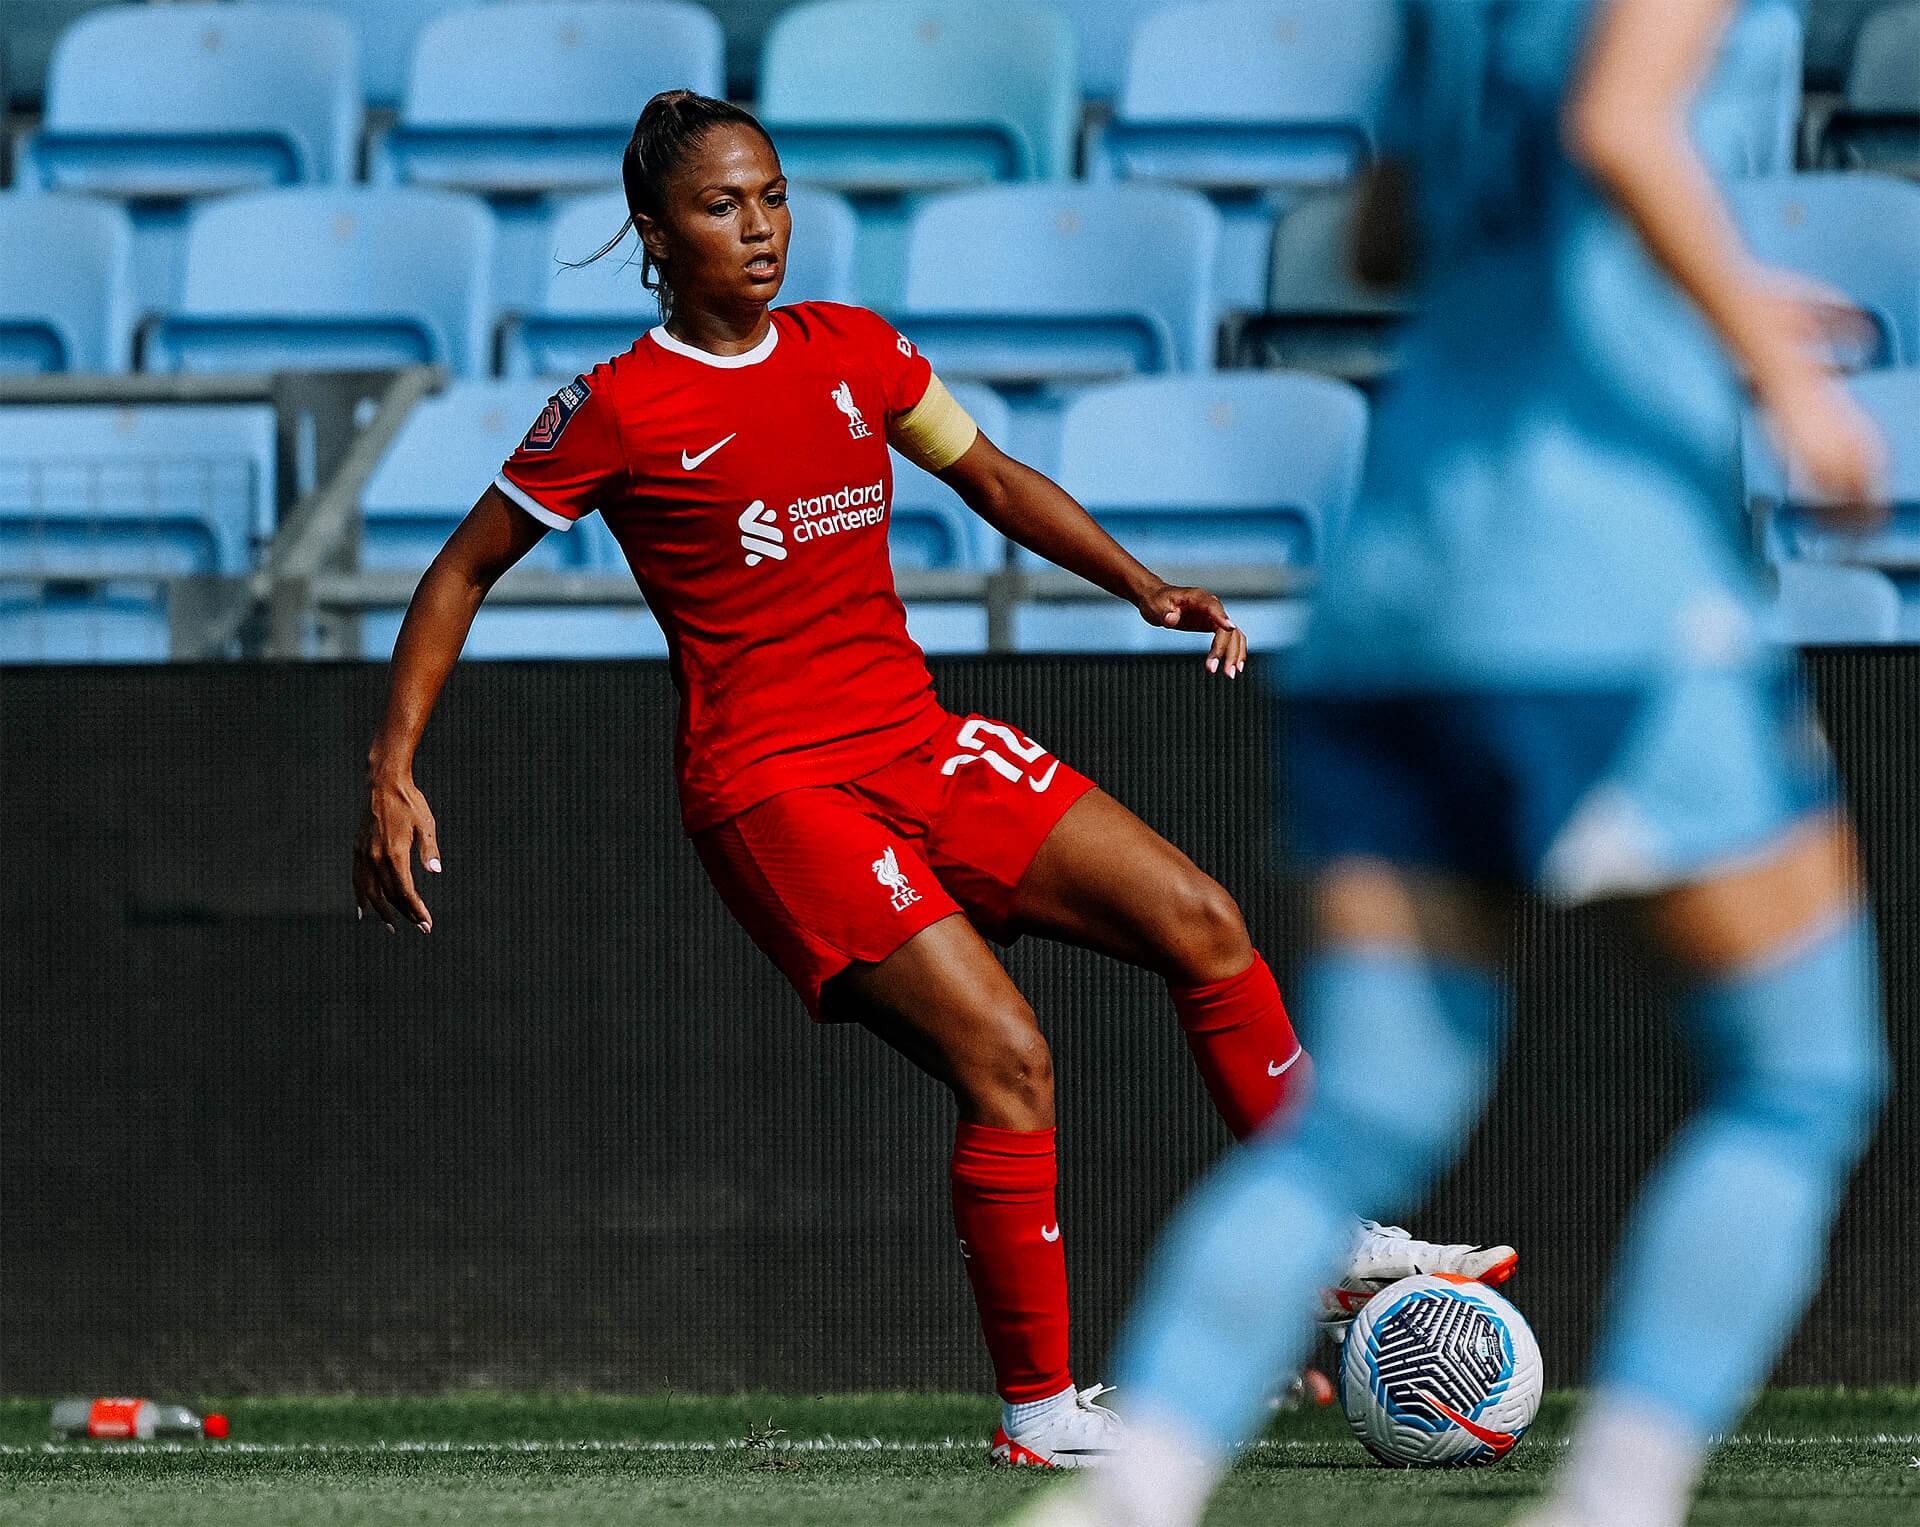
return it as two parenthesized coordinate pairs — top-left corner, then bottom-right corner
(824, 916), (1117, 1467)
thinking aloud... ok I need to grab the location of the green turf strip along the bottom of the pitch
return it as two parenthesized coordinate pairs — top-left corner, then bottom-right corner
(0, 1391), (1920, 1527)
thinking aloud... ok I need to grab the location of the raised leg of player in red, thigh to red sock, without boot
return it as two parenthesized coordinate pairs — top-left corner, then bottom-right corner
(1008, 789), (1313, 1139)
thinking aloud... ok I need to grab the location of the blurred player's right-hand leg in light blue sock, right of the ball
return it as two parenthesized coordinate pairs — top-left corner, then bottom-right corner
(1540, 818), (1885, 1527)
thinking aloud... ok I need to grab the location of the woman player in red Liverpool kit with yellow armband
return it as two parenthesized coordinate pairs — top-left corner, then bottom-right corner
(353, 92), (1515, 1466)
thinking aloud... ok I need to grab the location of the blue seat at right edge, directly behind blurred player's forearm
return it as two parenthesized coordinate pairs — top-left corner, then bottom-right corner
(1726, 175), (1920, 365)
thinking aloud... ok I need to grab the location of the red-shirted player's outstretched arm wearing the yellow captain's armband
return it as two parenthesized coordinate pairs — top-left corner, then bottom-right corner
(889, 376), (1246, 678)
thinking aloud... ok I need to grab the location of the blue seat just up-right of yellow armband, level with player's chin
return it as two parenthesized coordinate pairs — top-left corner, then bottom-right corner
(899, 184), (1219, 382)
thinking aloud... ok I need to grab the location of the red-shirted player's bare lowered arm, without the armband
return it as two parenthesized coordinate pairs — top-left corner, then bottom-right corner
(353, 486), (547, 933)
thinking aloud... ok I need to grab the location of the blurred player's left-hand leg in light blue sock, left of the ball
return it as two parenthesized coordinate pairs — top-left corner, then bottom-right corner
(1059, 862), (1500, 1527)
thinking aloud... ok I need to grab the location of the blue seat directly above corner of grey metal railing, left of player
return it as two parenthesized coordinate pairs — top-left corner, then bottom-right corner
(146, 186), (493, 376)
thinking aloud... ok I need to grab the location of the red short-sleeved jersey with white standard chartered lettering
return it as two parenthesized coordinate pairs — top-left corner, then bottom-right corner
(497, 302), (945, 832)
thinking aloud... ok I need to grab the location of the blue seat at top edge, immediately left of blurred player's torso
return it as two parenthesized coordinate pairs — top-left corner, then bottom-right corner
(1104, 0), (1400, 190)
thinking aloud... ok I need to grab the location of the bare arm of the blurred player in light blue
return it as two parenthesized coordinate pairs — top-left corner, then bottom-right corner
(1563, 0), (1884, 505)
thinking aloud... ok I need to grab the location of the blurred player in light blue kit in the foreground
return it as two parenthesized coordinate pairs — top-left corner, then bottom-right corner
(1025, 0), (1885, 1527)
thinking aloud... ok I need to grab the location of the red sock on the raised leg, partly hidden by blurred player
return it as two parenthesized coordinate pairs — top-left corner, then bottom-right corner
(1169, 955), (1313, 1139)
